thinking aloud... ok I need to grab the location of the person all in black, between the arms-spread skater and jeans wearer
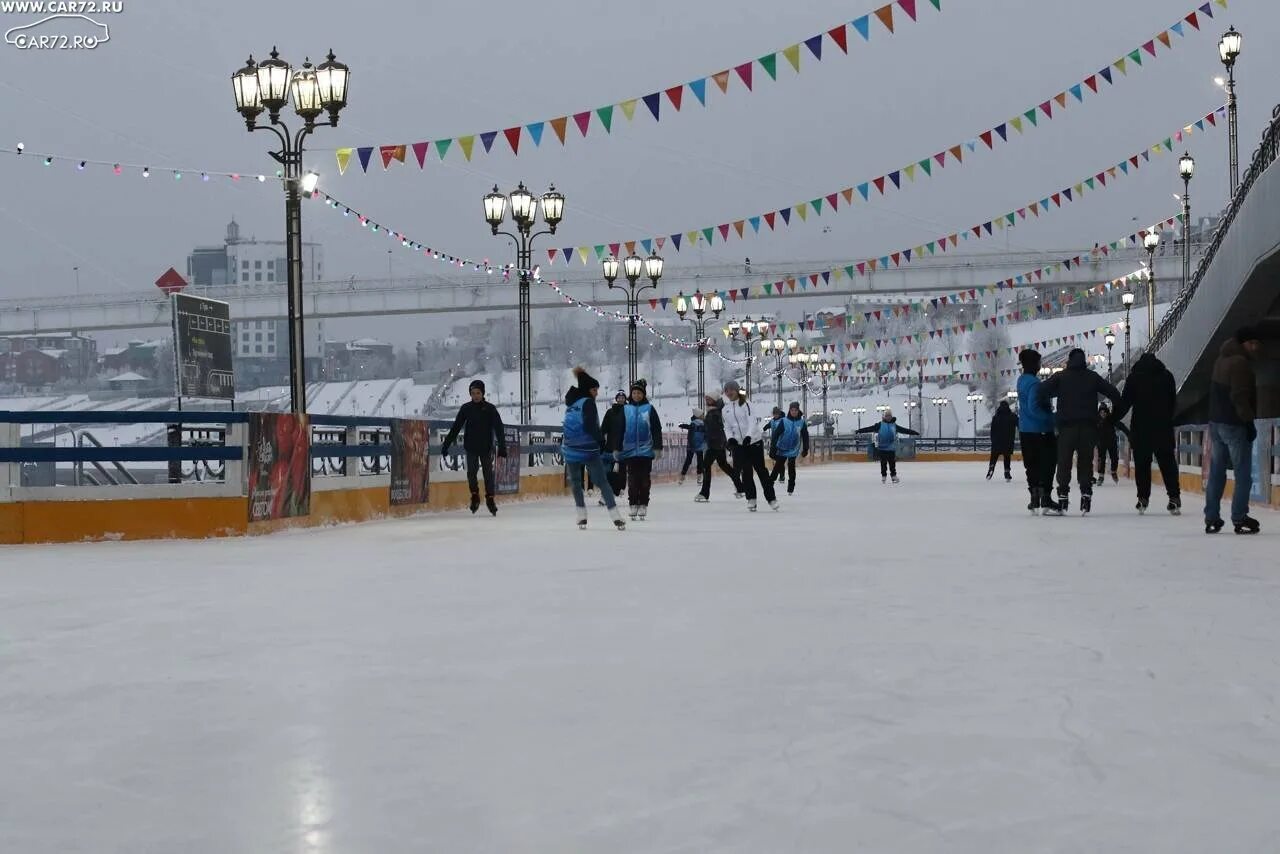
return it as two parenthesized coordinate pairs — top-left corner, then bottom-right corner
(1111, 353), (1183, 516)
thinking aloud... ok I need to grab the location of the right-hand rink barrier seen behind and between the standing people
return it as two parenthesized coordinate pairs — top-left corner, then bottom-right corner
(1120, 419), (1280, 510)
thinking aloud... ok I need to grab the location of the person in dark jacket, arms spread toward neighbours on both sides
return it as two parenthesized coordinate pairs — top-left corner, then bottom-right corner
(1038, 347), (1120, 513)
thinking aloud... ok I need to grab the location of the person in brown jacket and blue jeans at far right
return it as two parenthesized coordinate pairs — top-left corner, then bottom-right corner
(1204, 328), (1262, 534)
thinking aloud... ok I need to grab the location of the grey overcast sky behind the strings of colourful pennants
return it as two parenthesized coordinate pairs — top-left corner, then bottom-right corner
(0, 0), (1280, 348)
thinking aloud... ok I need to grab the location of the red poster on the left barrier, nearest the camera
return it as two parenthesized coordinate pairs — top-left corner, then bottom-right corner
(248, 412), (311, 522)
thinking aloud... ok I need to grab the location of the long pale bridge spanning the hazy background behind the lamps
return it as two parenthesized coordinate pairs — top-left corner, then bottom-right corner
(0, 247), (1180, 335)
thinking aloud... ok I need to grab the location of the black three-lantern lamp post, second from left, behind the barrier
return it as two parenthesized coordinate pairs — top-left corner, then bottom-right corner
(483, 182), (564, 424)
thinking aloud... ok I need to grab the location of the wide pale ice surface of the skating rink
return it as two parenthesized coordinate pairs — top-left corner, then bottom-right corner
(0, 463), (1280, 854)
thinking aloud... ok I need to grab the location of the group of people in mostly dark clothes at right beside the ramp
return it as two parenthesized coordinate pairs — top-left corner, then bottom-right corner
(1008, 328), (1261, 534)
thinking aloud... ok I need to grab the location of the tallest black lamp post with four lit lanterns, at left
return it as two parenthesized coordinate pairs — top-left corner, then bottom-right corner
(232, 47), (351, 415)
